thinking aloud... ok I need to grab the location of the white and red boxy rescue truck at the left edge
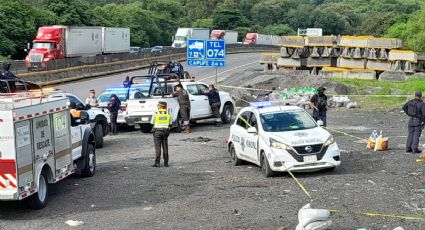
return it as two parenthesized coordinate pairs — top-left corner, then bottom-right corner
(0, 93), (96, 209)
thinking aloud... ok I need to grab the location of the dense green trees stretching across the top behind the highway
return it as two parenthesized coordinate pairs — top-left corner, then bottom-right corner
(0, 0), (425, 58)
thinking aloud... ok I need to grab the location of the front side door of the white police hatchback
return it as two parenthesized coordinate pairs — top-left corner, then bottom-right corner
(244, 112), (259, 163)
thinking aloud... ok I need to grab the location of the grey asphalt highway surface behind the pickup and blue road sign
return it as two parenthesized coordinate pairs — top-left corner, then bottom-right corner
(57, 53), (261, 99)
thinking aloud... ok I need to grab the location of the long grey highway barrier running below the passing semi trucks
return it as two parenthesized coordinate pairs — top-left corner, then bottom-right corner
(0, 44), (274, 74)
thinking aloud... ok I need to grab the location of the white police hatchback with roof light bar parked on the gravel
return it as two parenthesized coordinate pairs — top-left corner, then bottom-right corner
(228, 103), (341, 177)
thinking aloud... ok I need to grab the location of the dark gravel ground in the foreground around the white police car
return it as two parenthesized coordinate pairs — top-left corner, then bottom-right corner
(0, 110), (425, 230)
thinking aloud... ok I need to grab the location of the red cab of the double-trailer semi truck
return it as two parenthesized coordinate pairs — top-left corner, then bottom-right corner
(25, 26), (65, 69)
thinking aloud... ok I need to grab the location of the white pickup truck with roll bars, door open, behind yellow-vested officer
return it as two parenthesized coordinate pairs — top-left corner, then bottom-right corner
(126, 76), (235, 133)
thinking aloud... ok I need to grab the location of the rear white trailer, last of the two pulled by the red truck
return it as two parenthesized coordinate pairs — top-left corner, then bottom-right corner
(102, 27), (130, 53)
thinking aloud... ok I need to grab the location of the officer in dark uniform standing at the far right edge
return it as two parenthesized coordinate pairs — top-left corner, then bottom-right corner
(403, 91), (425, 153)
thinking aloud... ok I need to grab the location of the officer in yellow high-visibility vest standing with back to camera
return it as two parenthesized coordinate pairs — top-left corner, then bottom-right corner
(151, 102), (171, 167)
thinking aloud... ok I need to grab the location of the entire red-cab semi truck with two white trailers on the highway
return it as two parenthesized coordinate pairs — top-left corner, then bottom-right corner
(25, 26), (130, 69)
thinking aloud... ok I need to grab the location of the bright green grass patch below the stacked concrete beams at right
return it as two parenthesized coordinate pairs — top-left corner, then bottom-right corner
(332, 78), (425, 111)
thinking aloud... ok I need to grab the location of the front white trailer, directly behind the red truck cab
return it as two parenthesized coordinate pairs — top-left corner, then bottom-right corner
(65, 26), (102, 57)
